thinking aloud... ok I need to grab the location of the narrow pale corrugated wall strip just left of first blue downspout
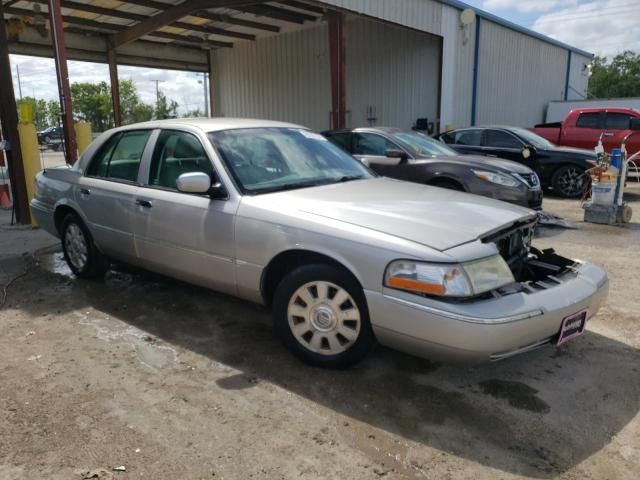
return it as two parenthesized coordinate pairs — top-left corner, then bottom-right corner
(440, 6), (476, 130)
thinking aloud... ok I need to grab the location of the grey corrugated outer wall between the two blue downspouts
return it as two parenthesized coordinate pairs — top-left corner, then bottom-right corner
(476, 20), (567, 126)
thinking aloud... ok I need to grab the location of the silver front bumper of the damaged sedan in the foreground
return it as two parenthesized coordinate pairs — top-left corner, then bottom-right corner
(365, 264), (609, 363)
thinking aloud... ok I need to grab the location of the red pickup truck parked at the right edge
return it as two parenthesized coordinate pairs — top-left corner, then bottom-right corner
(531, 107), (640, 154)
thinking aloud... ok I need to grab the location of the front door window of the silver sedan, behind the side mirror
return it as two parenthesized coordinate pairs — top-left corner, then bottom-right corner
(149, 130), (213, 190)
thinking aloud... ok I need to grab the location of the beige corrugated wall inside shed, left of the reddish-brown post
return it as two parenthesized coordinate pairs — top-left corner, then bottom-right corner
(212, 25), (331, 130)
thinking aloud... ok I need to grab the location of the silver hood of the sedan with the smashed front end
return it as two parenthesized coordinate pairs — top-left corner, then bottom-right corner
(252, 178), (535, 251)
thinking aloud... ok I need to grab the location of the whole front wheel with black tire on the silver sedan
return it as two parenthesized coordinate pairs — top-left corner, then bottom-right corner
(273, 265), (375, 369)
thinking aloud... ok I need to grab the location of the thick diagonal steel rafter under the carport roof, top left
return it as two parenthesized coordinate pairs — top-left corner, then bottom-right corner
(113, 0), (260, 47)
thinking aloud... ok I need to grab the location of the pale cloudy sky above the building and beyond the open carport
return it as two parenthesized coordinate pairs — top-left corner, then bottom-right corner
(11, 0), (640, 113)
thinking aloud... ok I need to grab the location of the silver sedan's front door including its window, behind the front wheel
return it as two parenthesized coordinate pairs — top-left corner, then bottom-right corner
(134, 130), (238, 293)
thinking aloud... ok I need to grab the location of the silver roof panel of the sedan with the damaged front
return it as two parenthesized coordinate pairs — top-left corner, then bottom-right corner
(110, 117), (306, 132)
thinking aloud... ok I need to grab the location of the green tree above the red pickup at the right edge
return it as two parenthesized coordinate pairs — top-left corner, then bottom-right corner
(587, 50), (640, 98)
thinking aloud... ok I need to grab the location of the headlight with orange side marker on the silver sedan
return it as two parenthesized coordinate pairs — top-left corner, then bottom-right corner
(384, 255), (515, 297)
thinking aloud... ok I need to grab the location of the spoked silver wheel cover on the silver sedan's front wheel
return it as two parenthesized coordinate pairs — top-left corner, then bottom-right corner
(287, 281), (361, 355)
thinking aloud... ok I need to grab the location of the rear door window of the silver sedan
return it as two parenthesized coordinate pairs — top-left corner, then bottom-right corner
(87, 130), (151, 182)
